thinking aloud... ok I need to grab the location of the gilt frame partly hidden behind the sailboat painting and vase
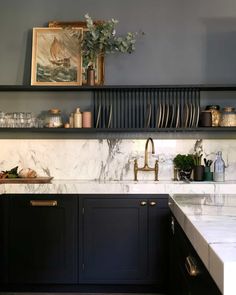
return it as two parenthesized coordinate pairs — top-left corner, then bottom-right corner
(48, 21), (104, 85)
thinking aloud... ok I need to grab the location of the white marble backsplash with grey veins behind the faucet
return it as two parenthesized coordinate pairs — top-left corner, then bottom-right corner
(0, 139), (236, 181)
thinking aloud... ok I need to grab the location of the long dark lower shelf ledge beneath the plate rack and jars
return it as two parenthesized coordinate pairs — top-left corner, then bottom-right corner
(0, 127), (236, 139)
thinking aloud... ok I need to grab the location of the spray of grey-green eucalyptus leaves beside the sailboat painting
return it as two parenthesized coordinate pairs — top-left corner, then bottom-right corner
(81, 14), (137, 62)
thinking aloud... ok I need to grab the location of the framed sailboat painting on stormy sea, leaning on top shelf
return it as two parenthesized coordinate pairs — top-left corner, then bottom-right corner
(31, 28), (83, 86)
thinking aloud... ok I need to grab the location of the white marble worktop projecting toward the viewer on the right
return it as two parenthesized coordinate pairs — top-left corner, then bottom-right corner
(169, 194), (236, 295)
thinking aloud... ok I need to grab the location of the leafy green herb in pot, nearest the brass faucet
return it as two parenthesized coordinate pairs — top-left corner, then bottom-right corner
(173, 154), (194, 180)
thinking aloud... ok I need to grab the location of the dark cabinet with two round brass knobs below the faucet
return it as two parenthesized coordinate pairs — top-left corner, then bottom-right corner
(79, 195), (169, 286)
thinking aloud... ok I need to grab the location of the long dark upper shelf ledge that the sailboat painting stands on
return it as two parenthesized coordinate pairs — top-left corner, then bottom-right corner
(0, 84), (236, 91)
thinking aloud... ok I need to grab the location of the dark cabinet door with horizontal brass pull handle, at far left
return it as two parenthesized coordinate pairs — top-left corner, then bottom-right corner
(9, 195), (77, 284)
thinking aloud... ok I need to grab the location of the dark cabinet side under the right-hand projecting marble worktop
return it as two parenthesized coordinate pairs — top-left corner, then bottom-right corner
(170, 217), (221, 295)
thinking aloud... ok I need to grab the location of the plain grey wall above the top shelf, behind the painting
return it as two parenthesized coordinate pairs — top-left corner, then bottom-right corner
(0, 0), (236, 84)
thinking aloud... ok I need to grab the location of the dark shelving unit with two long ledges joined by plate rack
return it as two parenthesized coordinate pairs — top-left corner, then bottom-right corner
(0, 84), (236, 139)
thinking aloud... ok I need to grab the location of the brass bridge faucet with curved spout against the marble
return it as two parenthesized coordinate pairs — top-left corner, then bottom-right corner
(134, 137), (158, 181)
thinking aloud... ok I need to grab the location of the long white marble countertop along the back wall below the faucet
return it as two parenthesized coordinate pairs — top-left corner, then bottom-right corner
(0, 179), (236, 194)
